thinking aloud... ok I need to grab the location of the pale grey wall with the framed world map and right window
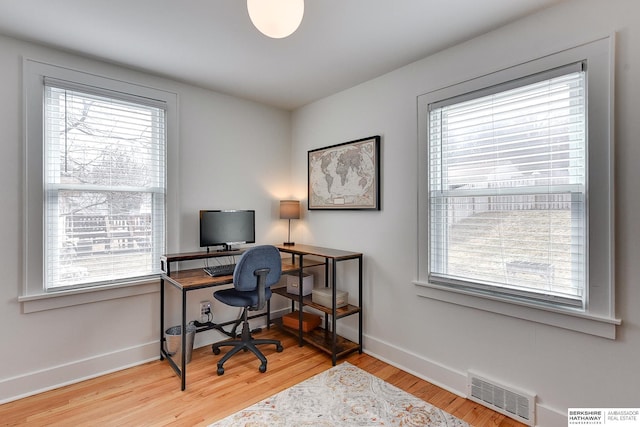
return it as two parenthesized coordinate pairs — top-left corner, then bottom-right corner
(292, 0), (640, 426)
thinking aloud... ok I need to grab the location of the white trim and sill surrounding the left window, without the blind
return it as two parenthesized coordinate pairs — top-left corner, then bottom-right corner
(18, 58), (179, 313)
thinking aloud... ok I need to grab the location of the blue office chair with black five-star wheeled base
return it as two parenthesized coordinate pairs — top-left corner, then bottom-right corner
(212, 245), (282, 375)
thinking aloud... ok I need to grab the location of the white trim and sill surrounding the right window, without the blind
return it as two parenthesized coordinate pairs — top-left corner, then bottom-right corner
(413, 35), (621, 339)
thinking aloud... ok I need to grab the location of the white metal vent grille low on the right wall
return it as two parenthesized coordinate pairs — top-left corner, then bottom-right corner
(467, 372), (536, 426)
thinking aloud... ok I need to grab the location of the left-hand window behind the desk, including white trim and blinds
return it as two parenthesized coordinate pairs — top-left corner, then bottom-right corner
(19, 60), (177, 312)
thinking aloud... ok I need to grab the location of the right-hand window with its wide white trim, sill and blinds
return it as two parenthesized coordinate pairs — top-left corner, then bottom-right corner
(417, 36), (619, 337)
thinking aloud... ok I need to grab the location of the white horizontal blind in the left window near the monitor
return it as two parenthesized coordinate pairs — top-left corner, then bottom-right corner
(44, 78), (166, 290)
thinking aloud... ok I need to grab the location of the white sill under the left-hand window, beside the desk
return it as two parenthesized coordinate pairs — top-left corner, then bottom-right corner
(18, 279), (160, 313)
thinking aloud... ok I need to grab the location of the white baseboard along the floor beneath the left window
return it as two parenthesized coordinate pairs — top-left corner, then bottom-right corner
(0, 341), (160, 404)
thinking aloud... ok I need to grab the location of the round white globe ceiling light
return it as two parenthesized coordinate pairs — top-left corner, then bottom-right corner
(247, 0), (304, 39)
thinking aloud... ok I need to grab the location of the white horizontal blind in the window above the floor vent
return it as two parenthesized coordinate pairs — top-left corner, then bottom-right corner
(428, 63), (588, 307)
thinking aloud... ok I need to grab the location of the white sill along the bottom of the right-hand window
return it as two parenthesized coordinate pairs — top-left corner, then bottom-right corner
(413, 281), (622, 339)
